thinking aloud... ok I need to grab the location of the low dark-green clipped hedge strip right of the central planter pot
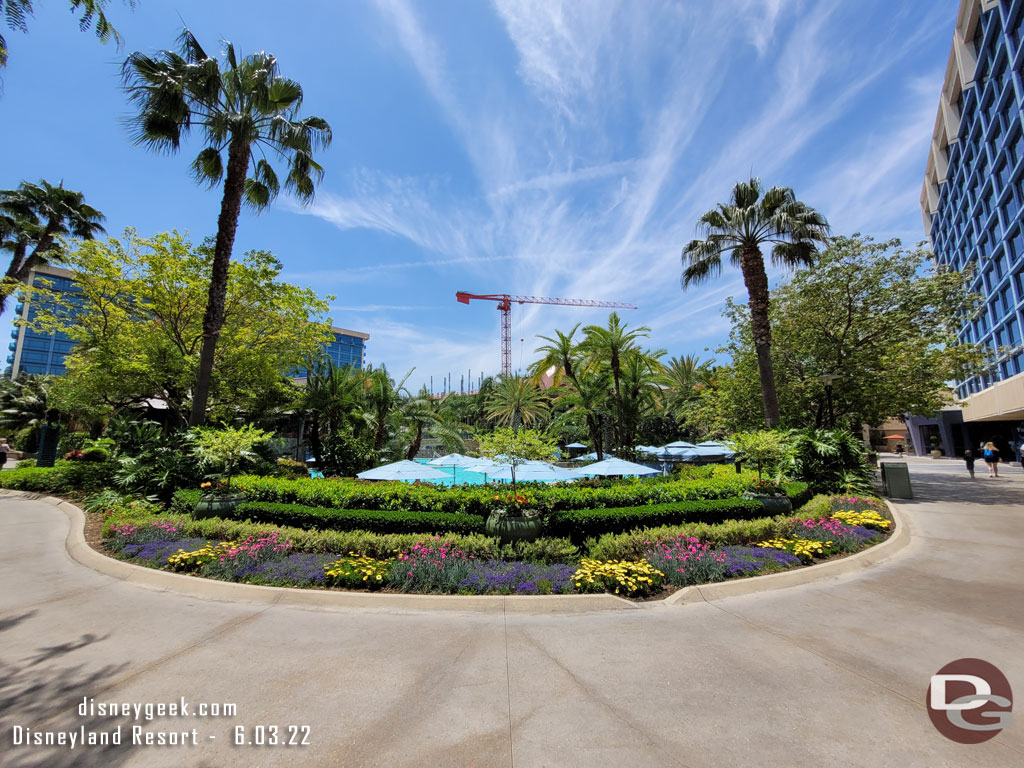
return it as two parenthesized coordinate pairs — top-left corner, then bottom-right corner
(548, 498), (764, 543)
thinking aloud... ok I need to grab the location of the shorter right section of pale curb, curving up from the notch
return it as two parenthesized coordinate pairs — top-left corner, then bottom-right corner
(662, 499), (910, 605)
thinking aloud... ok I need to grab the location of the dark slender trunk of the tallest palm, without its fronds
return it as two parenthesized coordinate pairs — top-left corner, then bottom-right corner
(188, 138), (249, 427)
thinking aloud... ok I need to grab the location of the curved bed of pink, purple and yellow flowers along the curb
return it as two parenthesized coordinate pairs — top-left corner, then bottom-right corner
(99, 505), (892, 598)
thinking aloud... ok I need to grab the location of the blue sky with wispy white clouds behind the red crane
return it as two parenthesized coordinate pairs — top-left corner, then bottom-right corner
(0, 0), (957, 389)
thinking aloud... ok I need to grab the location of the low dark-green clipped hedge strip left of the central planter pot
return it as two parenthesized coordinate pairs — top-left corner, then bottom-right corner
(217, 502), (483, 534)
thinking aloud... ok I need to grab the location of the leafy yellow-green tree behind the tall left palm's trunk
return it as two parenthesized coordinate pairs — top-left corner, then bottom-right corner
(29, 230), (331, 423)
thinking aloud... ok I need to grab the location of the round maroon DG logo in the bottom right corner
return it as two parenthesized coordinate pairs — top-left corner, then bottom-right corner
(927, 658), (1014, 744)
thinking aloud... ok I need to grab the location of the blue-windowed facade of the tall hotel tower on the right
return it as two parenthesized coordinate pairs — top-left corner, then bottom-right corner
(922, 0), (1024, 399)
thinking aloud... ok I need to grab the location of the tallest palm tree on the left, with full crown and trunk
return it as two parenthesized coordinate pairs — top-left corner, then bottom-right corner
(122, 29), (331, 426)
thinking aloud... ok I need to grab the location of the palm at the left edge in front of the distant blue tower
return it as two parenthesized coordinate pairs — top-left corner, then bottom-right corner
(0, 181), (103, 315)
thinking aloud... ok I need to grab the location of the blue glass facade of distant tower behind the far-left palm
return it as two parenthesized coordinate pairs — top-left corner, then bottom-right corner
(5, 269), (80, 376)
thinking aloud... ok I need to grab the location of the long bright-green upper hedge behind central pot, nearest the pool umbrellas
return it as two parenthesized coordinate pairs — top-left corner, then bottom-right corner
(237, 467), (756, 517)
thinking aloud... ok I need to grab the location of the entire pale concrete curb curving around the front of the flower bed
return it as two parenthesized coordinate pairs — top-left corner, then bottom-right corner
(0, 488), (910, 613)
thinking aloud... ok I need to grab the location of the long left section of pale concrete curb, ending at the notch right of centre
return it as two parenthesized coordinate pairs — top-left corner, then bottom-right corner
(0, 488), (640, 613)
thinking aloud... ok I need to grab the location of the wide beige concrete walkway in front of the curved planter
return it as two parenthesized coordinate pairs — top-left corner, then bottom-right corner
(0, 460), (1024, 768)
